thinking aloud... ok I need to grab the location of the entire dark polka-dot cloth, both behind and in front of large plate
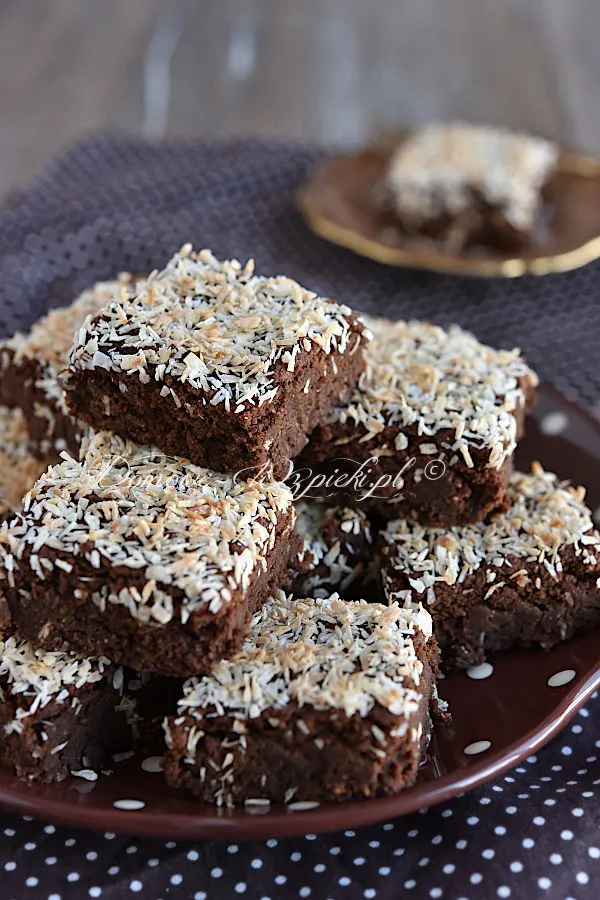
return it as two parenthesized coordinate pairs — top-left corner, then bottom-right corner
(0, 138), (600, 900)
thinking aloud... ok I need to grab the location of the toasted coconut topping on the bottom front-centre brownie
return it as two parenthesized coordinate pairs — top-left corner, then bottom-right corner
(171, 592), (431, 719)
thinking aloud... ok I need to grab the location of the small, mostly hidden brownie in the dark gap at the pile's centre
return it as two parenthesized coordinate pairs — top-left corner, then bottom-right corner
(291, 500), (372, 599)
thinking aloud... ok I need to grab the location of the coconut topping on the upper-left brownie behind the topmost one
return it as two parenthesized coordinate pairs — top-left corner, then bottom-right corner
(2, 272), (132, 414)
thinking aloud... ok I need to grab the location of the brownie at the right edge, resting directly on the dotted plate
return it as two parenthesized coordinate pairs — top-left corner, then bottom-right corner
(382, 465), (600, 669)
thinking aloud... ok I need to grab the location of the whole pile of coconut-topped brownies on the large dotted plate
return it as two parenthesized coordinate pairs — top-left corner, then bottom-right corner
(0, 246), (600, 807)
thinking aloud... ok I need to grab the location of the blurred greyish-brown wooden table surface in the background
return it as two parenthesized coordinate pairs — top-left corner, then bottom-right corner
(0, 0), (600, 193)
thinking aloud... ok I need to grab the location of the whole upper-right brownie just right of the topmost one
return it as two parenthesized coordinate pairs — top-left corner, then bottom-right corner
(299, 316), (537, 526)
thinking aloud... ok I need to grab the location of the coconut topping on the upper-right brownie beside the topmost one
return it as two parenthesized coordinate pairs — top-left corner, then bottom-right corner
(330, 315), (538, 468)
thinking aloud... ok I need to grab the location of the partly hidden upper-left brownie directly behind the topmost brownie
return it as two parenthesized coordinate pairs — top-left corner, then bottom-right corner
(0, 274), (132, 458)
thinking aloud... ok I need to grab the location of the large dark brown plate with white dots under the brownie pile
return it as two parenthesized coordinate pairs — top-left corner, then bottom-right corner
(0, 387), (600, 840)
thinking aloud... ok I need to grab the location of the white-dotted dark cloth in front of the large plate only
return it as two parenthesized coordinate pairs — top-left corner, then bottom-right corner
(0, 696), (600, 900)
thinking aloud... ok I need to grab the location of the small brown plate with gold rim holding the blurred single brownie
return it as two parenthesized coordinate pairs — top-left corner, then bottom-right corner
(298, 137), (600, 278)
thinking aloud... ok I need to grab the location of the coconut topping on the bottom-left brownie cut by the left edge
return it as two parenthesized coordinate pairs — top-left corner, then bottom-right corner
(0, 634), (111, 734)
